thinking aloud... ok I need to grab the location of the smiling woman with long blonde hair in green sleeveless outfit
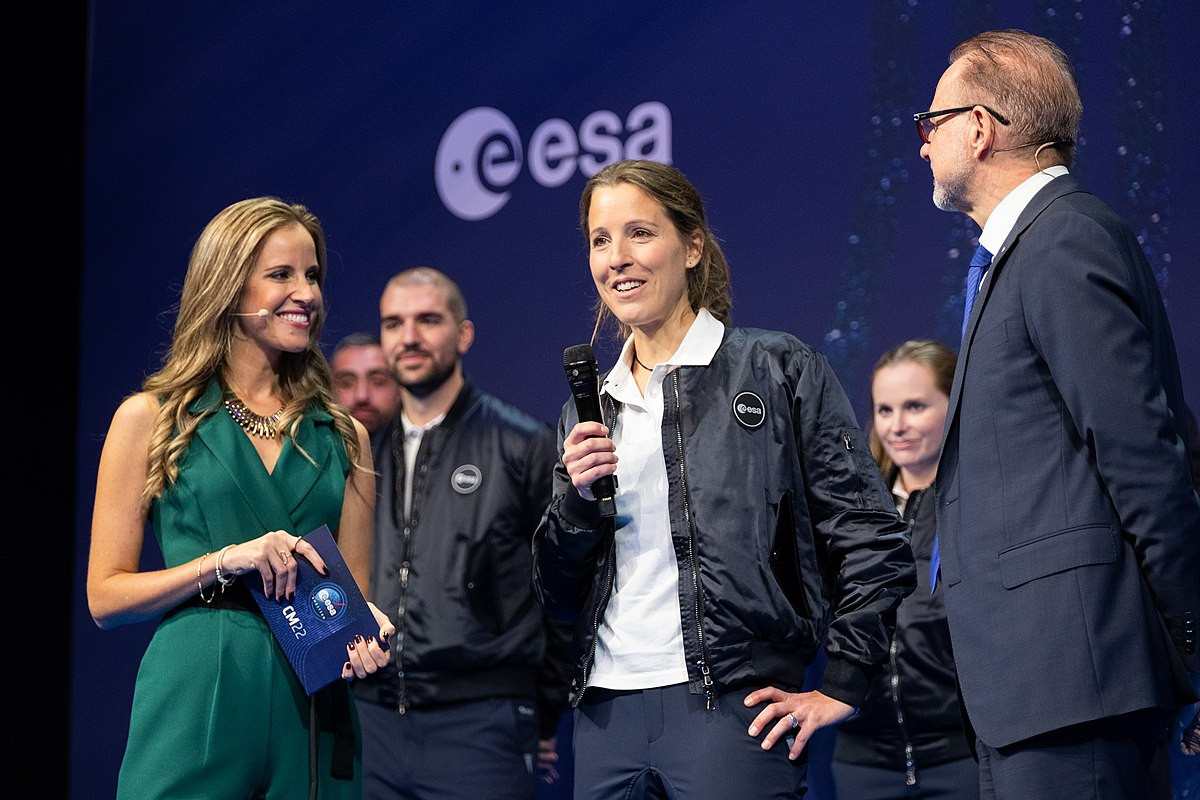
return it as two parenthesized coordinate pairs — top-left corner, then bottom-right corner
(88, 198), (392, 799)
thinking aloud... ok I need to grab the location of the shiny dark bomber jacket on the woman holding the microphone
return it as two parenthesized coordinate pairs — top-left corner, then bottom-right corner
(534, 327), (916, 706)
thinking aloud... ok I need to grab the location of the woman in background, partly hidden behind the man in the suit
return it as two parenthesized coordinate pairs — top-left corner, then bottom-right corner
(833, 339), (979, 800)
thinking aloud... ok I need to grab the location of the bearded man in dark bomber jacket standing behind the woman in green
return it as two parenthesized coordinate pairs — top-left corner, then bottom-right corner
(355, 267), (570, 800)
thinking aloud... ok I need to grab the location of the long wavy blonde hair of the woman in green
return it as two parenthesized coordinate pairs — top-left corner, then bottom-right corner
(142, 197), (360, 503)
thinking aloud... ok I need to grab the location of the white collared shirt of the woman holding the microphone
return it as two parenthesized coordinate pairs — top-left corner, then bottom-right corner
(589, 308), (725, 690)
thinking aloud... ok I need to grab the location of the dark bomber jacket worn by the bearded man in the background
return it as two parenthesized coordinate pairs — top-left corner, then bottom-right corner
(355, 380), (570, 738)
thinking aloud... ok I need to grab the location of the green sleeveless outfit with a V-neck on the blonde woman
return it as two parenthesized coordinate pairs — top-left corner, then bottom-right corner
(118, 380), (361, 800)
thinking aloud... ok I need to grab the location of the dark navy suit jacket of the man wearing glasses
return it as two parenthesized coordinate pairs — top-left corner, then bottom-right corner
(936, 175), (1200, 747)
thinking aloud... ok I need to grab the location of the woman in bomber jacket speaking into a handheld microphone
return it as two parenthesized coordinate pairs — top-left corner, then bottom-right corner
(535, 161), (914, 800)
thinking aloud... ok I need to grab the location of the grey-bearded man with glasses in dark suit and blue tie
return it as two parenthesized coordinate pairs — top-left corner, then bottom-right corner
(916, 31), (1200, 800)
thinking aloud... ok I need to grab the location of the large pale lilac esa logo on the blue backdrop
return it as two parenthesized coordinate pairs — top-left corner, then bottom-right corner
(433, 101), (671, 221)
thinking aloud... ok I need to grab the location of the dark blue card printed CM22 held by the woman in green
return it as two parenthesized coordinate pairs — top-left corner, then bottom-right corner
(246, 525), (388, 694)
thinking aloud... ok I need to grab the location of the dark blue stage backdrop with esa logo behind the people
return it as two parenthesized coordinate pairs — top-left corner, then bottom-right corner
(70, 0), (1200, 798)
